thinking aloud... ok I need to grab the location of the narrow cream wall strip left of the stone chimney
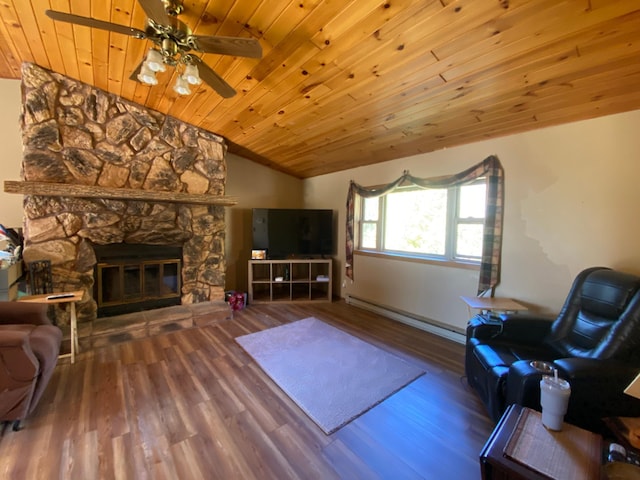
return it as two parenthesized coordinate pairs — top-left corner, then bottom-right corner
(0, 79), (22, 228)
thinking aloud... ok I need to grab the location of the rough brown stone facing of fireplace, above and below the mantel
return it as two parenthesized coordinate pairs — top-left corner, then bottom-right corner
(21, 64), (226, 323)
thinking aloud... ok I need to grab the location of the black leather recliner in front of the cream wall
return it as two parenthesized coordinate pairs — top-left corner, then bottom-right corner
(465, 267), (640, 431)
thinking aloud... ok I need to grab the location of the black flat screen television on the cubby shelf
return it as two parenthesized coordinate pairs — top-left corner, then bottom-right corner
(253, 208), (334, 260)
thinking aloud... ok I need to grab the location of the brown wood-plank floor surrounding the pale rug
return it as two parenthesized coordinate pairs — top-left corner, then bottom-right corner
(0, 302), (493, 480)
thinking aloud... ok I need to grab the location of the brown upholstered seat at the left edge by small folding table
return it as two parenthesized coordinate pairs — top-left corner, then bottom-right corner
(0, 302), (62, 430)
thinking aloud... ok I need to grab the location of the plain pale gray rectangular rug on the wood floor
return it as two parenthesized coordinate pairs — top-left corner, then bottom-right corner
(236, 317), (425, 434)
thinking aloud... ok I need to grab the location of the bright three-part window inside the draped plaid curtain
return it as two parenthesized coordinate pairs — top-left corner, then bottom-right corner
(357, 178), (486, 263)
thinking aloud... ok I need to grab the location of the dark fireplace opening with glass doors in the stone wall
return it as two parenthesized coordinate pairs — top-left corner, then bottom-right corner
(94, 243), (182, 317)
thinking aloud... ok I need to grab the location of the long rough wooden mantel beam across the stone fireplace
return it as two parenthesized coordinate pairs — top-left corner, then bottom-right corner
(4, 180), (238, 207)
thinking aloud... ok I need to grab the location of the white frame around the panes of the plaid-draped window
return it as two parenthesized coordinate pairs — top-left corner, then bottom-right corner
(354, 177), (487, 268)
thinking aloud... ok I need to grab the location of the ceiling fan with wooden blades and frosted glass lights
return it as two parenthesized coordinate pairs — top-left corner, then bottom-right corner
(45, 0), (262, 98)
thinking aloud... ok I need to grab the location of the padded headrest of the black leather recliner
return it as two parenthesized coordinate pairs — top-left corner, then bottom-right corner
(581, 270), (640, 319)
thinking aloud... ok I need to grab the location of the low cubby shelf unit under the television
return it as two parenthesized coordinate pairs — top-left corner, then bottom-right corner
(249, 259), (333, 303)
